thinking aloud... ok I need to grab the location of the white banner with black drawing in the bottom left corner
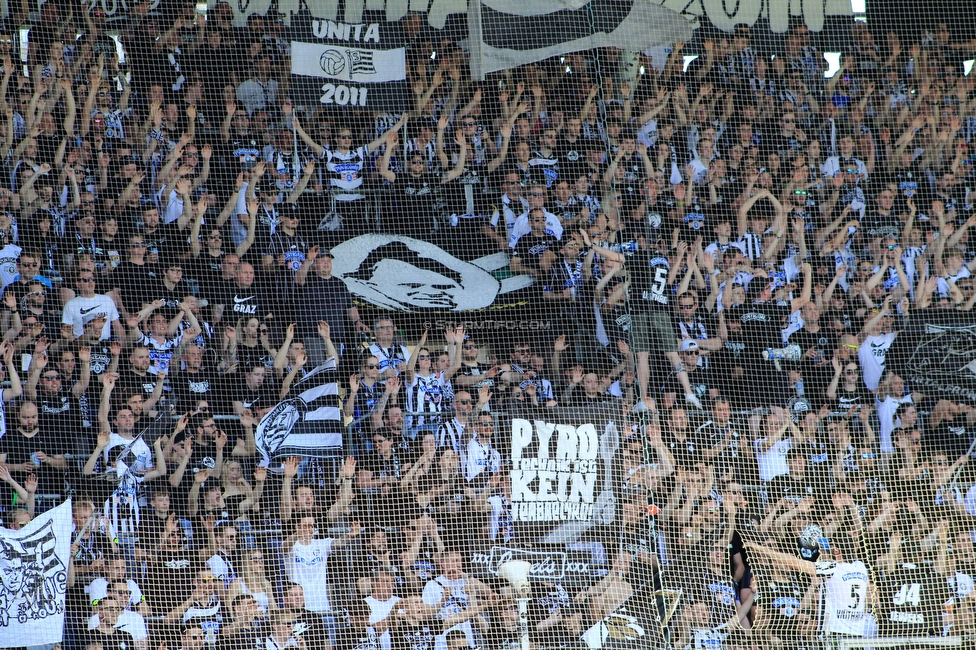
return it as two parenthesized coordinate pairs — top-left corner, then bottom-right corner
(0, 499), (71, 648)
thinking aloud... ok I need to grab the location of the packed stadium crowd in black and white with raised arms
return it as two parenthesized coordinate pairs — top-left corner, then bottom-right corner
(0, 0), (976, 650)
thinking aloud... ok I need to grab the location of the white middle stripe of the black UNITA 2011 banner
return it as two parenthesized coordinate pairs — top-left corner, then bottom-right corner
(291, 41), (407, 83)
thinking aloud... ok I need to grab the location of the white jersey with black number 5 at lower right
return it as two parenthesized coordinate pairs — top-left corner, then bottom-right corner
(817, 560), (868, 636)
